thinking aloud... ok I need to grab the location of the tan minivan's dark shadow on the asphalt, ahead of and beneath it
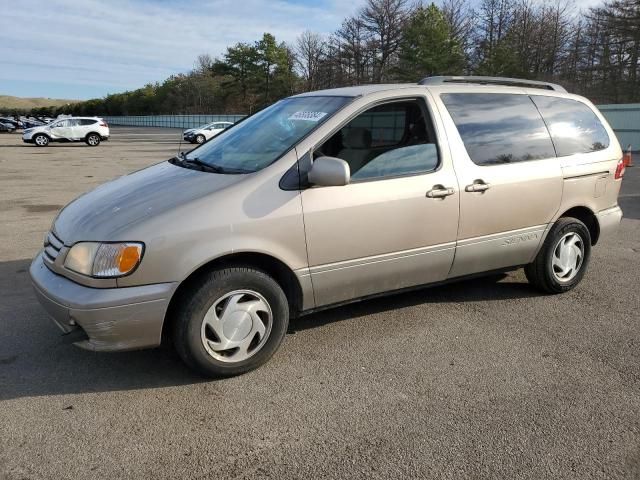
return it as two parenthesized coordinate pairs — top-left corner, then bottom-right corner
(0, 259), (538, 401)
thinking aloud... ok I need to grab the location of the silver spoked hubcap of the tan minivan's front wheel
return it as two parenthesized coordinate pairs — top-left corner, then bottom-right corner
(201, 290), (273, 363)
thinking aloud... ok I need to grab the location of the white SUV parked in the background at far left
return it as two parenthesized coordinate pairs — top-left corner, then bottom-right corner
(22, 117), (109, 147)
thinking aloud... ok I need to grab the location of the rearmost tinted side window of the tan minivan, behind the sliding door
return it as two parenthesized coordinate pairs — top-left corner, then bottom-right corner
(531, 95), (609, 157)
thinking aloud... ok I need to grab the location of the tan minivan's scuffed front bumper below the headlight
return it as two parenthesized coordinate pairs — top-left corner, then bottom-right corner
(29, 252), (177, 351)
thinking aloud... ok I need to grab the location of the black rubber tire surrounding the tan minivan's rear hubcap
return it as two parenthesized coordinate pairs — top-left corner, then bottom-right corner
(524, 217), (591, 294)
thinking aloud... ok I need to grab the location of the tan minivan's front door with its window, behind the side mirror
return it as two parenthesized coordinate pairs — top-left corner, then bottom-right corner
(301, 98), (459, 306)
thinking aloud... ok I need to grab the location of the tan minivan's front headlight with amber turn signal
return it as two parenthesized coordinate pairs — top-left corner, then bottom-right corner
(64, 242), (144, 278)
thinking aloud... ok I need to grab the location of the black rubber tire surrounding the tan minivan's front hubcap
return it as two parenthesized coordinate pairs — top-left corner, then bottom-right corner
(172, 267), (289, 378)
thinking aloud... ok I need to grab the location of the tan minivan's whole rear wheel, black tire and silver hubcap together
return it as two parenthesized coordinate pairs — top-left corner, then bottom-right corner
(524, 218), (591, 293)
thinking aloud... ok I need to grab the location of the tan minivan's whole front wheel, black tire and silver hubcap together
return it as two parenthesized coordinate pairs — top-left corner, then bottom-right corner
(173, 267), (289, 377)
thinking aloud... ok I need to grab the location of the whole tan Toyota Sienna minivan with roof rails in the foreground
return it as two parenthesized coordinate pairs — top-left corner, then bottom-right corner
(30, 77), (624, 376)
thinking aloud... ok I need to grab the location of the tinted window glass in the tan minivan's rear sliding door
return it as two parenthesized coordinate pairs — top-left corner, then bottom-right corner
(442, 93), (556, 165)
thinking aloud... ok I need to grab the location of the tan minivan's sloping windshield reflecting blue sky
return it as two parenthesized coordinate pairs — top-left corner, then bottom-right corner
(186, 97), (350, 173)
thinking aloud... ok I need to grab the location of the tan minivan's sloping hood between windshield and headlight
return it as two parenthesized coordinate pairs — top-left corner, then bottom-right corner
(53, 162), (245, 246)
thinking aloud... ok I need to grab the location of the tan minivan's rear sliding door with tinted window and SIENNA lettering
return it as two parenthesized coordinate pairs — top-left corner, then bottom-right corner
(439, 90), (562, 277)
